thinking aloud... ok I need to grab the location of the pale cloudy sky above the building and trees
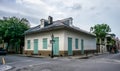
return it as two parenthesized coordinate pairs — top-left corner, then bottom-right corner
(0, 0), (120, 38)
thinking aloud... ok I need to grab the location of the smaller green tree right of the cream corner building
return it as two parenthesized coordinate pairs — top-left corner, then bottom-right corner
(90, 24), (111, 43)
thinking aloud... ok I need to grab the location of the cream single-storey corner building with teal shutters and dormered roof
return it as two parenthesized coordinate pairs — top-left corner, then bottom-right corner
(24, 16), (96, 56)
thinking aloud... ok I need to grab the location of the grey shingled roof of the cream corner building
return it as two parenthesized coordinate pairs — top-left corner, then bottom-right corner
(25, 19), (95, 36)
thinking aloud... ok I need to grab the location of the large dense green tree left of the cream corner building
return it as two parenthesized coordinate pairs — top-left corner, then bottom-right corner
(0, 17), (30, 53)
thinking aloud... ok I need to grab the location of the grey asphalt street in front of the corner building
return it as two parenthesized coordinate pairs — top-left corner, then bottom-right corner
(0, 53), (120, 71)
